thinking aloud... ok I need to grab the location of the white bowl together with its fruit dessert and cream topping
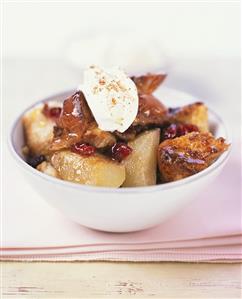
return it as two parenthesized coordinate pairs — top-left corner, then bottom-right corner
(10, 66), (229, 232)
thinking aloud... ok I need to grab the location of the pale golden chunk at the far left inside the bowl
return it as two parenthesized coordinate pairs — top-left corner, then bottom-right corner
(23, 107), (55, 155)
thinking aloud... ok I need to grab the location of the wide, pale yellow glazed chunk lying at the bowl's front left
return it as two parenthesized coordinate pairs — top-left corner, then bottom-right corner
(51, 150), (125, 187)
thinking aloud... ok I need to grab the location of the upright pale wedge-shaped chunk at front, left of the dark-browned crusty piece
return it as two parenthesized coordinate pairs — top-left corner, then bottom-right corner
(123, 129), (160, 187)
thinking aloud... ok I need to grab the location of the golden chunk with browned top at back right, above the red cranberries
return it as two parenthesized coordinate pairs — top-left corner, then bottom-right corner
(168, 102), (208, 132)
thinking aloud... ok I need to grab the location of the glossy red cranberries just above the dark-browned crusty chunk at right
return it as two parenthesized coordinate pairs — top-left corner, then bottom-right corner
(162, 124), (199, 139)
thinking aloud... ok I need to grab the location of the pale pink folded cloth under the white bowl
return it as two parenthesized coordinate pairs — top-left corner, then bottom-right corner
(1, 141), (242, 262)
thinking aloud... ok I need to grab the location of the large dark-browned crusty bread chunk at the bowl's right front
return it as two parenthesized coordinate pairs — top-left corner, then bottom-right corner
(158, 132), (229, 182)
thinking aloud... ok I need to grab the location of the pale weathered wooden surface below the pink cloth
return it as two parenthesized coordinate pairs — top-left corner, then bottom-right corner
(1, 262), (242, 298)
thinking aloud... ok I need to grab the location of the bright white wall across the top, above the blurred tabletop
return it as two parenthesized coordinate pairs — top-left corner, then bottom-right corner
(3, 1), (240, 58)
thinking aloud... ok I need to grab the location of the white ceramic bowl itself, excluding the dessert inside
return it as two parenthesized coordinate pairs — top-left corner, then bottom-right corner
(9, 88), (230, 232)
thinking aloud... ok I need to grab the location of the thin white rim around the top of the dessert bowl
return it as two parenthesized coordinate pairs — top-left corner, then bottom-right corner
(8, 88), (232, 194)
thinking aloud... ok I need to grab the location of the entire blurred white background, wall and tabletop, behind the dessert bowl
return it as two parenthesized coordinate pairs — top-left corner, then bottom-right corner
(3, 1), (241, 137)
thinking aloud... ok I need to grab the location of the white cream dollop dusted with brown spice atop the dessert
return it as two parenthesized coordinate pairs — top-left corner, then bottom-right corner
(79, 65), (139, 133)
